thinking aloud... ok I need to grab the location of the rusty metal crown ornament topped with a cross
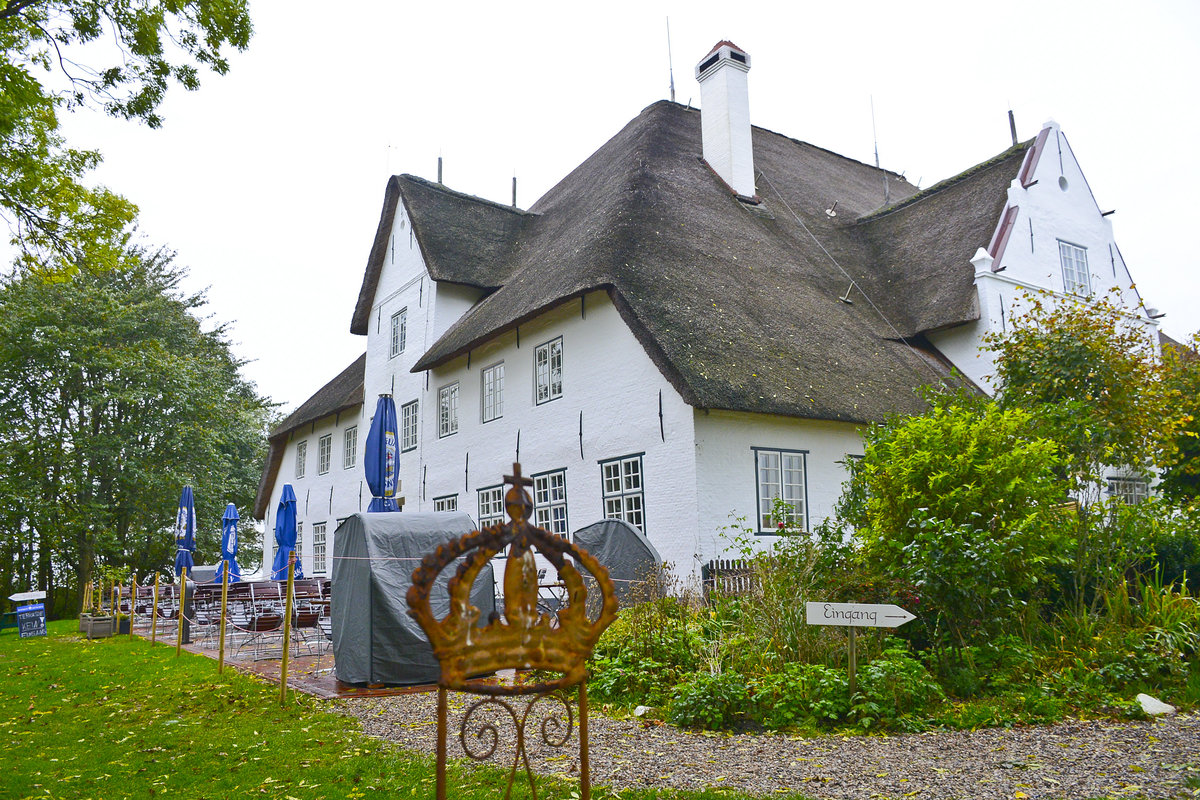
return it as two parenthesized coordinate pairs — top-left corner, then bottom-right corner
(407, 463), (618, 694)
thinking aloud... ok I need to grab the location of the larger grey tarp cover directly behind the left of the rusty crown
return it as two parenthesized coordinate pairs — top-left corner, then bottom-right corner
(330, 511), (496, 684)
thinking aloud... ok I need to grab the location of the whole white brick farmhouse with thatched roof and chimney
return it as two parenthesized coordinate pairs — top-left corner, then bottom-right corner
(256, 42), (1156, 575)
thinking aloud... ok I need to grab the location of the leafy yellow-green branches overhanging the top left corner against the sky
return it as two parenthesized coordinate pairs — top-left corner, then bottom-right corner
(0, 0), (251, 270)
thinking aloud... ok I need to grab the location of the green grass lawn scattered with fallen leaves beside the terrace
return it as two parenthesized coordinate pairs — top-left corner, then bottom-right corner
(0, 620), (799, 800)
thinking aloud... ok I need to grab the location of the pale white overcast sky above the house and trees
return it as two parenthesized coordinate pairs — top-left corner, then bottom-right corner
(46, 0), (1200, 413)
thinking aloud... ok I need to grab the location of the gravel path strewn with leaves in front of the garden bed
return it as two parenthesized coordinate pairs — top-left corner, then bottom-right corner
(338, 692), (1200, 800)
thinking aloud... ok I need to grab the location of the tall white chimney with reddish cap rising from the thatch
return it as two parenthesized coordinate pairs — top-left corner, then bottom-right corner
(696, 42), (755, 197)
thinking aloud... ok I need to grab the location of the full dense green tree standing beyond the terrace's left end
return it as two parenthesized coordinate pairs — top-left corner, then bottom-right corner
(0, 248), (269, 609)
